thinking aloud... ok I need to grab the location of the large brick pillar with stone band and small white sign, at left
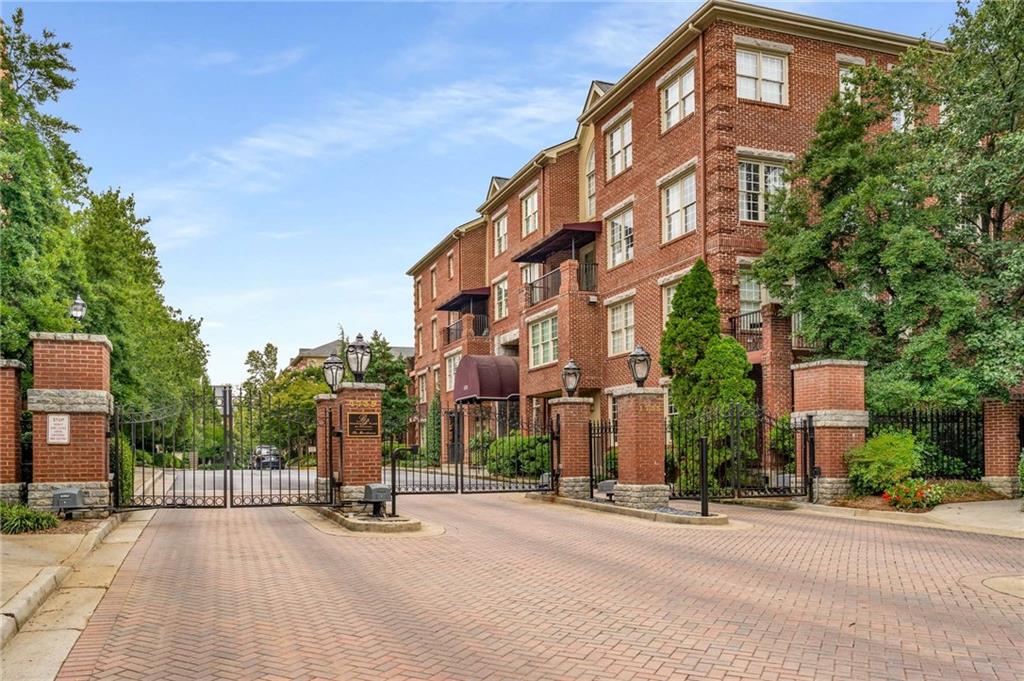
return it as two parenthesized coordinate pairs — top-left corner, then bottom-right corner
(29, 332), (114, 517)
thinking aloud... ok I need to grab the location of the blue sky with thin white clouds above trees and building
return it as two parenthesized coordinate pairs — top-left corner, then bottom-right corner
(18, 0), (954, 382)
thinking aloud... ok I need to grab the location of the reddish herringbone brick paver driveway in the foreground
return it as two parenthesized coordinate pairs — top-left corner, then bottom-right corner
(61, 496), (1024, 679)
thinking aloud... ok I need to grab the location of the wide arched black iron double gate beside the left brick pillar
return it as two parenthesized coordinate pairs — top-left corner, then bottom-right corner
(110, 386), (333, 508)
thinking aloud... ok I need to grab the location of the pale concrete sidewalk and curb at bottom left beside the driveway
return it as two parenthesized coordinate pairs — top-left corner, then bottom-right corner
(0, 511), (156, 681)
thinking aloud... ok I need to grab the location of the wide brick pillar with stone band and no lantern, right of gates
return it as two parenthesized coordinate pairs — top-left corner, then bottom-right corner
(793, 359), (867, 503)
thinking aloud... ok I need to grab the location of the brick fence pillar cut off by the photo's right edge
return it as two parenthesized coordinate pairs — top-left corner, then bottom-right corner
(981, 386), (1024, 497)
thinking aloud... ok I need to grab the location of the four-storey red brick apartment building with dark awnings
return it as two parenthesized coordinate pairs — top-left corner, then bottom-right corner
(408, 0), (933, 440)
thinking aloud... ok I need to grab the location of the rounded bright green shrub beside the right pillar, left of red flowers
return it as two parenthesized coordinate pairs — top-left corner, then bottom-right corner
(846, 430), (921, 495)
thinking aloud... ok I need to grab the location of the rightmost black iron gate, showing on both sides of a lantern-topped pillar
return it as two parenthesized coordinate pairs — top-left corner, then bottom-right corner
(590, 405), (814, 499)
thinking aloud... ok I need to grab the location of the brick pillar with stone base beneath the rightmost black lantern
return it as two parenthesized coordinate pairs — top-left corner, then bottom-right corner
(611, 387), (669, 508)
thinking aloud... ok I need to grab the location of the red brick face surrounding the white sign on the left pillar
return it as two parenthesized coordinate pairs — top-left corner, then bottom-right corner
(32, 413), (110, 482)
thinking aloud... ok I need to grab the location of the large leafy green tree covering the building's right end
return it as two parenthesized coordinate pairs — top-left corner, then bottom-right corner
(756, 1), (1024, 409)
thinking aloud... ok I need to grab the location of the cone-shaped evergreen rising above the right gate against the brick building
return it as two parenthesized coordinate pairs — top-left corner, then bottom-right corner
(659, 259), (756, 414)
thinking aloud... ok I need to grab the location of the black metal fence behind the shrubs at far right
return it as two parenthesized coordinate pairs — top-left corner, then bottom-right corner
(867, 410), (985, 480)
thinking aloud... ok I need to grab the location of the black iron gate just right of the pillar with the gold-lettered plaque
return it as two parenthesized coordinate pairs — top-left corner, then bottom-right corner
(381, 402), (559, 495)
